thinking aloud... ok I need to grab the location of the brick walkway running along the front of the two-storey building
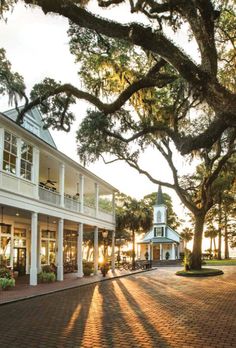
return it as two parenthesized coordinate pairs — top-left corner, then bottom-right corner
(0, 270), (151, 305)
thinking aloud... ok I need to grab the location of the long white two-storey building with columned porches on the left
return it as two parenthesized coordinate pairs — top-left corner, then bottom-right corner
(0, 109), (116, 285)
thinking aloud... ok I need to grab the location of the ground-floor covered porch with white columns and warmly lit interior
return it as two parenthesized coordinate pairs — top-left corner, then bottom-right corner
(0, 205), (115, 285)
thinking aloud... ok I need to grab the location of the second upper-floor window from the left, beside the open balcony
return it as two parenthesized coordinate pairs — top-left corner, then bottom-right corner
(20, 141), (33, 180)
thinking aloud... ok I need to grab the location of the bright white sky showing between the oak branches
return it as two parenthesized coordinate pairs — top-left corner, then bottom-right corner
(0, 1), (199, 226)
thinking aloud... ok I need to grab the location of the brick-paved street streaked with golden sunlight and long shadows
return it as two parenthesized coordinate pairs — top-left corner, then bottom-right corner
(0, 266), (236, 348)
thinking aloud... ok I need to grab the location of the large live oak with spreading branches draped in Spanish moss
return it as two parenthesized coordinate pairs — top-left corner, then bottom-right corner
(0, 0), (236, 268)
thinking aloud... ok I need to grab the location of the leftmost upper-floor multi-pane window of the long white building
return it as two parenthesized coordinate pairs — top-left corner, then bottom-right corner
(3, 132), (17, 174)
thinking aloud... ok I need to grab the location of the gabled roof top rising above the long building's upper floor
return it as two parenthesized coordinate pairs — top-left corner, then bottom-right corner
(3, 106), (57, 149)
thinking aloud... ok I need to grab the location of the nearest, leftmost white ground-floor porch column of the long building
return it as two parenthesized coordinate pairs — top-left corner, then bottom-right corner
(30, 212), (38, 285)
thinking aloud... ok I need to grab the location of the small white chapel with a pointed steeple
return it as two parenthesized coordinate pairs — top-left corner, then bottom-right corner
(139, 186), (181, 261)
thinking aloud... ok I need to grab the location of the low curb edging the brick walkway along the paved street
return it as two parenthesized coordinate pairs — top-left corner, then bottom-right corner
(0, 267), (157, 307)
